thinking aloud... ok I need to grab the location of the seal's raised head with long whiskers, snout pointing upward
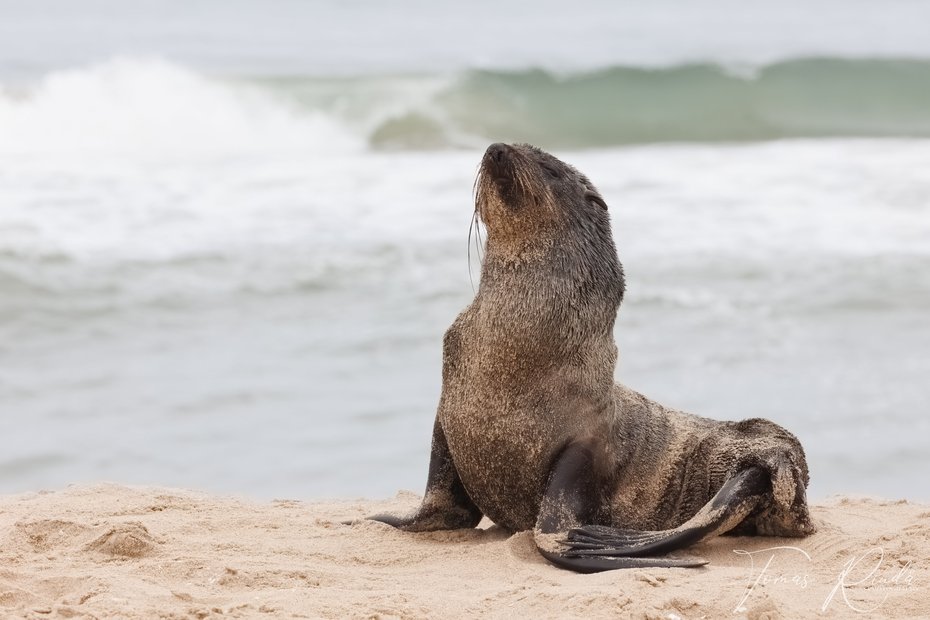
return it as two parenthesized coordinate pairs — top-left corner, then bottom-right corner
(475, 143), (614, 260)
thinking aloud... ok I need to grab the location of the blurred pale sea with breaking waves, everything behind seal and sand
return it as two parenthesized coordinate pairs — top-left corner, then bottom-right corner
(0, 0), (930, 500)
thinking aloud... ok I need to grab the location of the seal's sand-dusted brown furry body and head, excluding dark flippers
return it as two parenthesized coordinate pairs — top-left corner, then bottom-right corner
(437, 145), (813, 535)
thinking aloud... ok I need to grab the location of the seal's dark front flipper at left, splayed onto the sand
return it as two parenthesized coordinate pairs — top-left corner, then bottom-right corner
(368, 419), (481, 532)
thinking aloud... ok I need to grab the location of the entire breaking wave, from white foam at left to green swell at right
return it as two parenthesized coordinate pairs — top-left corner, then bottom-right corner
(0, 58), (930, 156)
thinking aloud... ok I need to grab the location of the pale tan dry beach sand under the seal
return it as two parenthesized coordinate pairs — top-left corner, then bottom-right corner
(0, 484), (930, 619)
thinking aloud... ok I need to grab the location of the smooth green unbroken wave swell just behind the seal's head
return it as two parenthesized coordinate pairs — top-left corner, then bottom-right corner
(402, 58), (930, 148)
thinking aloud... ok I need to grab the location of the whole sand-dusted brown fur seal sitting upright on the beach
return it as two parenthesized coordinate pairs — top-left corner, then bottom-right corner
(370, 144), (814, 572)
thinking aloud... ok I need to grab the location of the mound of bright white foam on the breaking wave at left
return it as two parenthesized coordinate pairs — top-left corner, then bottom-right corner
(0, 58), (364, 159)
